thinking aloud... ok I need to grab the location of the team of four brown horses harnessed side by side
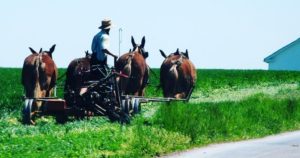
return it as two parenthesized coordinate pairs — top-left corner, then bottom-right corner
(22, 37), (197, 123)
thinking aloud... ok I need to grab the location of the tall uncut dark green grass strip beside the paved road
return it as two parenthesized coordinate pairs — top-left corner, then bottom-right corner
(154, 92), (300, 145)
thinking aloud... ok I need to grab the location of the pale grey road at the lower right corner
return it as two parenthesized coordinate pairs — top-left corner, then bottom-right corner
(165, 131), (300, 158)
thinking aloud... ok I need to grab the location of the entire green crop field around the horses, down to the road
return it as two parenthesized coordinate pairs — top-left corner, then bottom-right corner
(0, 68), (300, 158)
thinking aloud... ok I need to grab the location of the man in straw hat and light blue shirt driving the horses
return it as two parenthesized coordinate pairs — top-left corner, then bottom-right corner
(90, 19), (116, 79)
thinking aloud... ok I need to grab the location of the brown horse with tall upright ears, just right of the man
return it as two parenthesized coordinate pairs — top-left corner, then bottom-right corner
(116, 37), (149, 96)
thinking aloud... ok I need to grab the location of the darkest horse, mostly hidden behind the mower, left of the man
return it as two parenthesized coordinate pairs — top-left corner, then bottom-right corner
(64, 51), (91, 98)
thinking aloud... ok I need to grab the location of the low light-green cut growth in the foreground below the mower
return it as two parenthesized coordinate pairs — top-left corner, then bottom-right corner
(0, 117), (190, 157)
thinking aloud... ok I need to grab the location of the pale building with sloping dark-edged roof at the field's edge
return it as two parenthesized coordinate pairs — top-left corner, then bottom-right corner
(264, 38), (300, 71)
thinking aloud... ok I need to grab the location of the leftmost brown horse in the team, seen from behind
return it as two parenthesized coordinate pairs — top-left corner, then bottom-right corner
(22, 45), (58, 123)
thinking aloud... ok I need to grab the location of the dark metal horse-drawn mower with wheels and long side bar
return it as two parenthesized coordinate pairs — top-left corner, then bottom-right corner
(23, 53), (193, 124)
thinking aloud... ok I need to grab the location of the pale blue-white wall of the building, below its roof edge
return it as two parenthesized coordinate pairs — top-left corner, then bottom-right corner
(269, 43), (300, 71)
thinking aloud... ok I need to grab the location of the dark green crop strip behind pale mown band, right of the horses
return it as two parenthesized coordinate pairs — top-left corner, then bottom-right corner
(196, 70), (300, 92)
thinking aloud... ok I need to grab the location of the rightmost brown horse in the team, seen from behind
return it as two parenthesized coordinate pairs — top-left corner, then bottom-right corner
(160, 49), (197, 99)
